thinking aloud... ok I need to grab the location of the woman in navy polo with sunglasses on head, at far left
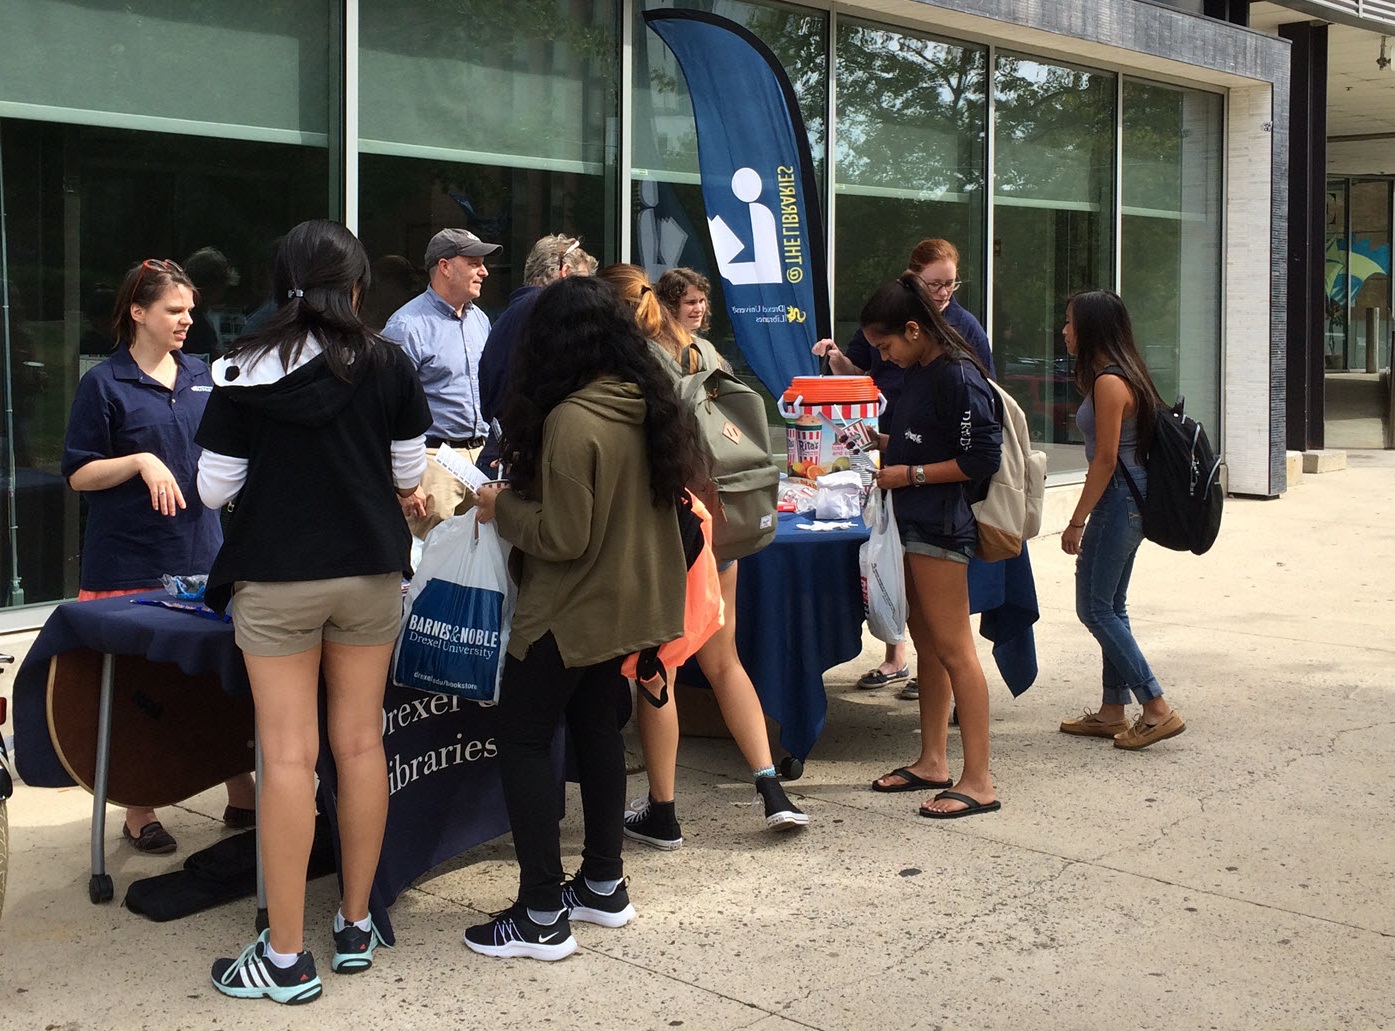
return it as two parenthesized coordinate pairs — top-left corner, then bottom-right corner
(63, 258), (257, 855)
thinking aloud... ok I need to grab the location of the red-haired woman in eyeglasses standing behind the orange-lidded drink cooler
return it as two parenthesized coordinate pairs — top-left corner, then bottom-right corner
(813, 237), (996, 705)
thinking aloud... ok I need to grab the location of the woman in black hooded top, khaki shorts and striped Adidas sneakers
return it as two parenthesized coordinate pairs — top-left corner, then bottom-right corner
(198, 220), (431, 1004)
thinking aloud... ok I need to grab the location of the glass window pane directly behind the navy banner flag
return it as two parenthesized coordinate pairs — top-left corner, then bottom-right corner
(629, 0), (829, 393)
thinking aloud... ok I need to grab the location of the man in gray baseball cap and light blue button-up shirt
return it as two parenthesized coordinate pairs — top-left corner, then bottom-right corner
(382, 229), (502, 537)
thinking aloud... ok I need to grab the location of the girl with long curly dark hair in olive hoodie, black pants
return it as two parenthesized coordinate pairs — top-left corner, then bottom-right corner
(465, 276), (703, 960)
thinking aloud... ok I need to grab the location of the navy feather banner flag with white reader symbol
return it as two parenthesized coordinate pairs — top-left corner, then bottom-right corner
(644, 11), (831, 396)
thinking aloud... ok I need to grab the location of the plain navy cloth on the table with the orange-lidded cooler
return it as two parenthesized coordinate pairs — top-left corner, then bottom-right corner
(719, 513), (1039, 760)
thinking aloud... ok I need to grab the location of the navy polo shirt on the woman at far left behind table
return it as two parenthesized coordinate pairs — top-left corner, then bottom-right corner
(61, 345), (223, 590)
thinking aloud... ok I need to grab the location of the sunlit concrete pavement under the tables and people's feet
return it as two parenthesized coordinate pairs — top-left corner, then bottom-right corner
(0, 452), (1395, 1031)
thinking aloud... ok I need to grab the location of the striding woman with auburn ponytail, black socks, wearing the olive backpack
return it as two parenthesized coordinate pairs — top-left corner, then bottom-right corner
(600, 264), (809, 851)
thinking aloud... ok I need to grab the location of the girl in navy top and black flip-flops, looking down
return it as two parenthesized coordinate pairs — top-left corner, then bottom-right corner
(861, 272), (1003, 819)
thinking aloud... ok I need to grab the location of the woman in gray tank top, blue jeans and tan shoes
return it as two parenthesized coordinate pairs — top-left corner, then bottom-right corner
(1060, 290), (1187, 749)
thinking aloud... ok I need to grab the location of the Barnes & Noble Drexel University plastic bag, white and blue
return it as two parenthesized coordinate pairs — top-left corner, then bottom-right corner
(392, 509), (518, 703)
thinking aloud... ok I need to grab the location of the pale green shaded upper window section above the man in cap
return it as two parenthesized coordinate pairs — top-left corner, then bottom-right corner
(359, 0), (619, 174)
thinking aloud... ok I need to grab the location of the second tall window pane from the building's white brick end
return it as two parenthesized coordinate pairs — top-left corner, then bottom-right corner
(992, 54), (1117, 472)
